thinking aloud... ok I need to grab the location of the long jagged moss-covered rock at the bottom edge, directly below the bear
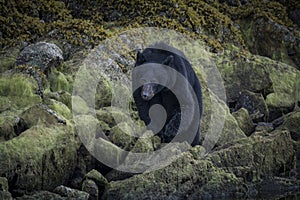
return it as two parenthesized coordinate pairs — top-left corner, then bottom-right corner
(103, 153), (241, 199)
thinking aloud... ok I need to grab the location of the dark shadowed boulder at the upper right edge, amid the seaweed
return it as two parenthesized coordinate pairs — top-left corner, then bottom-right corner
(240, 16), (300, 66)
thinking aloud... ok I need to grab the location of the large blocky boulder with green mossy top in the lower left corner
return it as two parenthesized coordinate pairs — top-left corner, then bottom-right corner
(0, 125), (77, 191)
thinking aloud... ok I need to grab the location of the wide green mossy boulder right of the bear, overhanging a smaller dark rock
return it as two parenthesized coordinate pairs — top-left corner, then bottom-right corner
(215, 49), (297, 121)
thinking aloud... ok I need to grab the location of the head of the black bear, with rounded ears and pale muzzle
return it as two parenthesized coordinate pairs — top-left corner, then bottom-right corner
(133, 49), (174, 101)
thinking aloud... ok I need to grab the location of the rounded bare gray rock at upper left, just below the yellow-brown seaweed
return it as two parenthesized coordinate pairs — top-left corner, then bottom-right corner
(16, 42), (63, 73)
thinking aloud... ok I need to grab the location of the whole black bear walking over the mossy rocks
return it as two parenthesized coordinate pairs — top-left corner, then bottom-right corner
(132, 43), (202, 146)
